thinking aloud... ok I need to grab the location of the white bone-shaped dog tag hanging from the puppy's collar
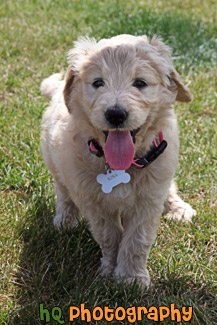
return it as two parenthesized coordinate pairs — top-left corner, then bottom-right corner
(96, 169), (131, 193)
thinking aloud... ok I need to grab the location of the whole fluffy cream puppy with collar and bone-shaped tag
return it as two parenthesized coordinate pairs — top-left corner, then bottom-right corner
(41, 35), (195, 286)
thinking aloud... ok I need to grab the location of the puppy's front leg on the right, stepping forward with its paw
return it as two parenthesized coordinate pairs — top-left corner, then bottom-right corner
(115, 208), (161, 287)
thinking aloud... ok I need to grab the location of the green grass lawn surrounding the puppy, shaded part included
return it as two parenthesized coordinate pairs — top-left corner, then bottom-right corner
(0, 0), (217, 324)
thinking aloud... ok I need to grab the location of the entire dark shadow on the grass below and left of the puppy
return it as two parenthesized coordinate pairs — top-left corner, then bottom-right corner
(8, 194), (214, 324)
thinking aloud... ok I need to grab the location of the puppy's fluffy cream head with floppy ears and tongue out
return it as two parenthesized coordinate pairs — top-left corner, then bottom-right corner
(64, 35), (191, 169)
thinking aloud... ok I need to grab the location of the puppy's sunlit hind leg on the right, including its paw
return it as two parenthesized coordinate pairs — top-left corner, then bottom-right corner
(164, 181), (196, 222)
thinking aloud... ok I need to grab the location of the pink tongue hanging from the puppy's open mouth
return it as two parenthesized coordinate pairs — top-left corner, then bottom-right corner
(104, 131), (135, 170)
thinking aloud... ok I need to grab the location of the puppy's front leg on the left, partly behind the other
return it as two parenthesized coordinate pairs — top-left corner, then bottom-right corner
(85, 209), (123, 277)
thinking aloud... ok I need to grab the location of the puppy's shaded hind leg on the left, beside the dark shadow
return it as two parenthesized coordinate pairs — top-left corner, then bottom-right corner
(53, 181), (81, 228)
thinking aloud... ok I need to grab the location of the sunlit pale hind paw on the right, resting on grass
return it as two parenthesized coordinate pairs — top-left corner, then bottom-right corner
(165, 199), (197, 222)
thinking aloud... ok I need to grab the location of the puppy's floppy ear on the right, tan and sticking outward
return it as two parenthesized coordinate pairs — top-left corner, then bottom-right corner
(169, 69), (193, 103)
